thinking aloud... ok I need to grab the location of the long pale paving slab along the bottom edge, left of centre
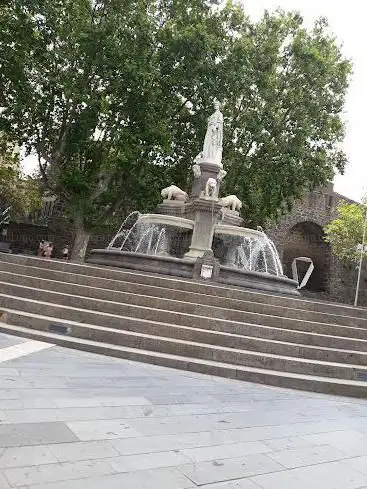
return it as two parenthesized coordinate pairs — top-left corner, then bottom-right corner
(15, 469), (196, 489)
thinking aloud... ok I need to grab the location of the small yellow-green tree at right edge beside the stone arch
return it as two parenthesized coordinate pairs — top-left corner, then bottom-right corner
(324, 202), (367, 262)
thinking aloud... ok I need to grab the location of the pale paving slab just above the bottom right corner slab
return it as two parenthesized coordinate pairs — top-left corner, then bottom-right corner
(268, 445), (345, 469)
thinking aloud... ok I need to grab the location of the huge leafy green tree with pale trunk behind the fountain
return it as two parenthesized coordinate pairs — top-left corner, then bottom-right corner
(0, 0), (350, 259)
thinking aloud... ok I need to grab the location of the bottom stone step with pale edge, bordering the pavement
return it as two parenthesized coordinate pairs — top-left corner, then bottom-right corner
(0, 323), (367, 398)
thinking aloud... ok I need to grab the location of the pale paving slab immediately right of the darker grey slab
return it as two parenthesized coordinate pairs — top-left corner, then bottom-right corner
(66, 419), (141, 441)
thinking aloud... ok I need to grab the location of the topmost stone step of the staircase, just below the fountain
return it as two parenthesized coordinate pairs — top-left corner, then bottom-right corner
(0, 254), (367, 318)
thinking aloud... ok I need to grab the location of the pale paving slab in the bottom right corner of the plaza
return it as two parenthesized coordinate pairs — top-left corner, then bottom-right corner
(251, 461), (367, 489)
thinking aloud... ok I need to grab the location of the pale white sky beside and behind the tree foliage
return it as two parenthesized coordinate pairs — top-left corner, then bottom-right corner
(23, 0), (367, 200)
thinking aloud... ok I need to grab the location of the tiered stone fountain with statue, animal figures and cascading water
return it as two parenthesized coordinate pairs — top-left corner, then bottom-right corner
(88, 102), (299, 295)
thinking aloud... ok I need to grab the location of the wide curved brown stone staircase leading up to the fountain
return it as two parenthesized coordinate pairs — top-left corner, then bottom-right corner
(0, 253), (367, 398)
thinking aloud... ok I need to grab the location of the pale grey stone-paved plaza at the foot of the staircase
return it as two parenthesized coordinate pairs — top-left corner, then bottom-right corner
(0, 334), (367, 489)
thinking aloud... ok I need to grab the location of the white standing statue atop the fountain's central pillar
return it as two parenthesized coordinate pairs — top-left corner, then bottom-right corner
(202, 101), (223, 166)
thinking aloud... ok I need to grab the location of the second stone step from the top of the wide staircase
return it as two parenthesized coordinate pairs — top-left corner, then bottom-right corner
(0, 262), (367, 328)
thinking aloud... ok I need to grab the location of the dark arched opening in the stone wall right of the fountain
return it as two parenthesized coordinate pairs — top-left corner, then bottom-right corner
(283, 221), (331, 292)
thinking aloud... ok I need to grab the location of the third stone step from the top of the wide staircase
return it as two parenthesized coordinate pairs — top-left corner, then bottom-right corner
(0, 282), (367, 339)
